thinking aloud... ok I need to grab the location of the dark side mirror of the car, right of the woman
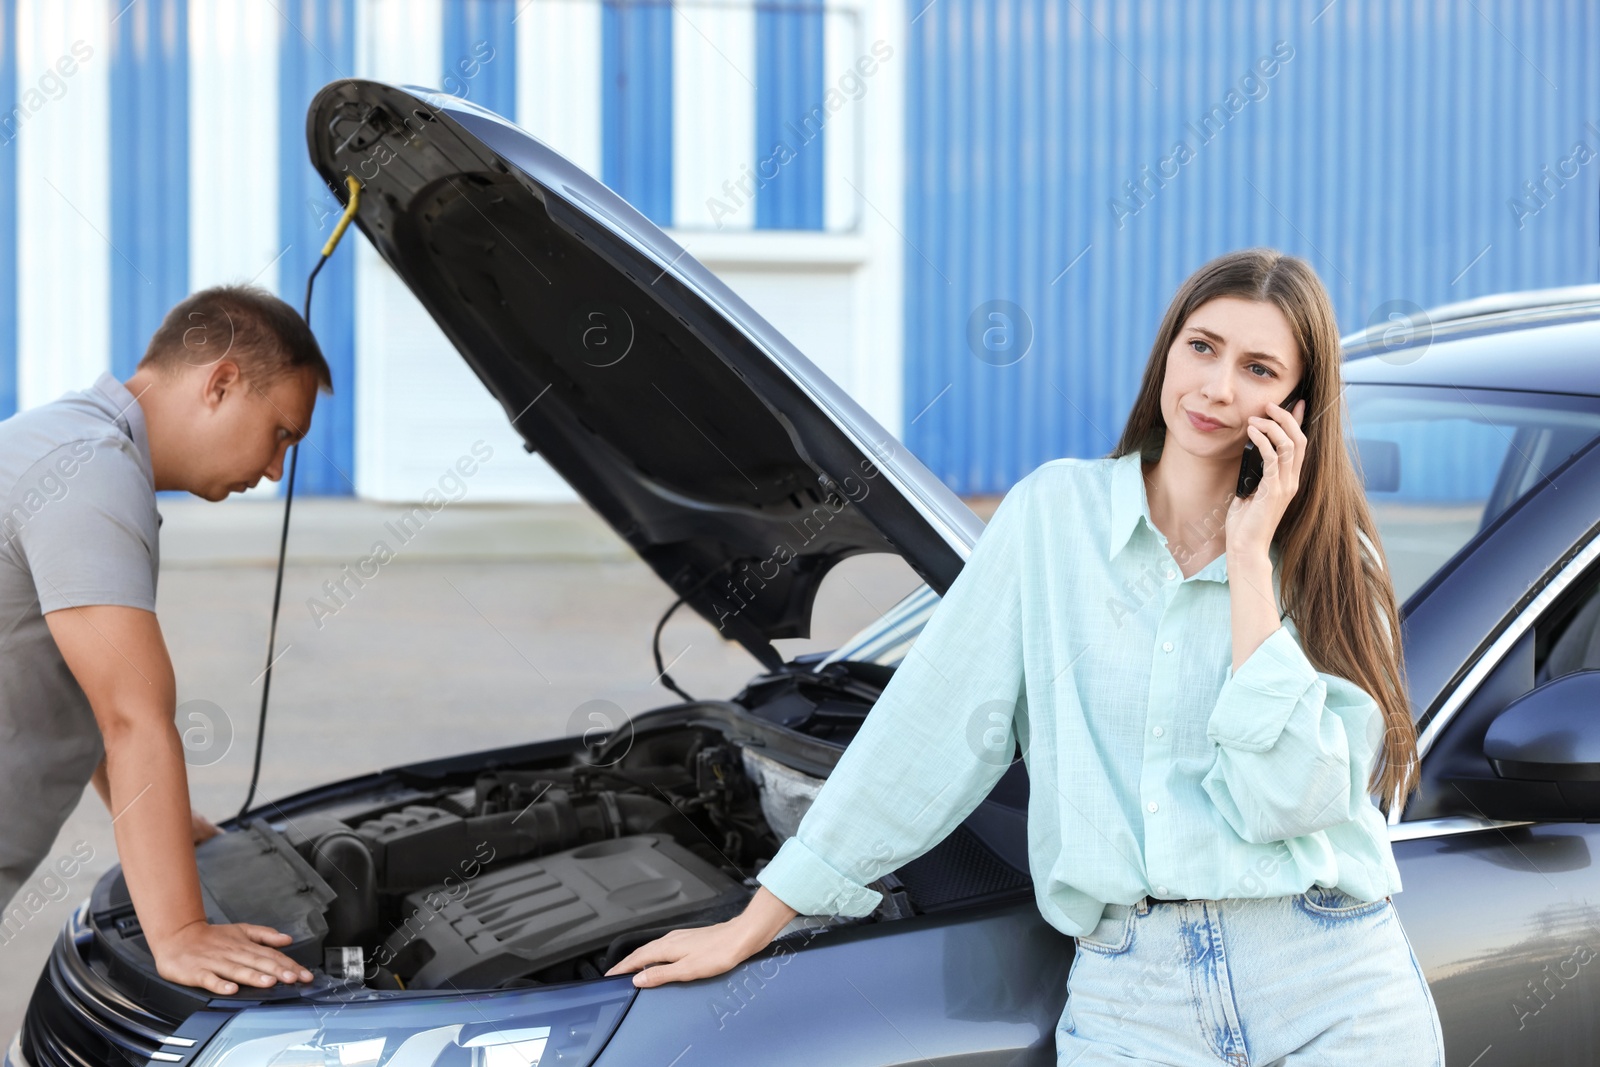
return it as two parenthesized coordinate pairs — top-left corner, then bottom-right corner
(1478, 670), (1600, 819)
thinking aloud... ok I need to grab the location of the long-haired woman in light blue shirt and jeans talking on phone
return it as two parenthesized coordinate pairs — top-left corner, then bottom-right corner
(610, 248), (1445, 1067)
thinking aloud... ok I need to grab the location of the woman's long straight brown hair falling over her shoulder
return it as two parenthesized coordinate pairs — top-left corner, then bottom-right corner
(1110, 248), (1418, 814)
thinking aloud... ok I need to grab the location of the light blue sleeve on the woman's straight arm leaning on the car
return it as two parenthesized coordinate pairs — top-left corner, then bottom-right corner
(757, 475), (1032, 917)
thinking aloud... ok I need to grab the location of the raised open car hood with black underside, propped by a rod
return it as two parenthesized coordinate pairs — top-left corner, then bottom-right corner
(306, 80), (982, 669)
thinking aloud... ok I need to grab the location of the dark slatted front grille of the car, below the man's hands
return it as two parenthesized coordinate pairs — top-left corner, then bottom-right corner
(22, 901), (194, 1067)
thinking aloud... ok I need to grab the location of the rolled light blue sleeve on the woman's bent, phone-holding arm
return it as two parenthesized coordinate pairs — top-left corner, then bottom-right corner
(1202, 625), (1384, 845)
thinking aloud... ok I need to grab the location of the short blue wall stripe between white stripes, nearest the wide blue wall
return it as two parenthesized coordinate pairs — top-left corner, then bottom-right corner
(755, 0), (829, 230)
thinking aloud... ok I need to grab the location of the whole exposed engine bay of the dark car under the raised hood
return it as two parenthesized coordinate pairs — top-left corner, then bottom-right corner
(91, 687), (1030, 990)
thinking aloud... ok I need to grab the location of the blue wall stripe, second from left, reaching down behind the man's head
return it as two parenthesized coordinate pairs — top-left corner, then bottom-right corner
(110, 0), (189, 378)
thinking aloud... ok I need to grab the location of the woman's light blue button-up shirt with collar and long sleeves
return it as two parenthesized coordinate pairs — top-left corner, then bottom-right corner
(757, 453), (1400, 936)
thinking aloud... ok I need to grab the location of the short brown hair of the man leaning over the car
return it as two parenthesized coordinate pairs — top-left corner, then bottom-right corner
(139, 285), (333, 392)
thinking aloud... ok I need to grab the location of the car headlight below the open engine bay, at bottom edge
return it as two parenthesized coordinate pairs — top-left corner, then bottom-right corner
(194, 977), (637, 1067)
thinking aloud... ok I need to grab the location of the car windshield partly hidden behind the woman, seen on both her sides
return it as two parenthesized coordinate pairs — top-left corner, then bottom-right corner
(818, 384), (1600, 669)
